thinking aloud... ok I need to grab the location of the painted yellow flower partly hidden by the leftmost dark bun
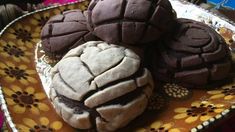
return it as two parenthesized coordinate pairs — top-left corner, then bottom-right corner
(30, 12), (50, 34)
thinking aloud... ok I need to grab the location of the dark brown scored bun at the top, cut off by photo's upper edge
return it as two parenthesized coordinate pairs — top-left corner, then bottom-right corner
(87, 0), (175, 44)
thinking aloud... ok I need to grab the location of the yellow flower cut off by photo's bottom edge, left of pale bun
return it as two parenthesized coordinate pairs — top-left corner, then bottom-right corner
(16, 117), (63, 132)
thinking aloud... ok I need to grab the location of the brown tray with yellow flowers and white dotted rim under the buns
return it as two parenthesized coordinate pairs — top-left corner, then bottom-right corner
(0, 0), (235, 132)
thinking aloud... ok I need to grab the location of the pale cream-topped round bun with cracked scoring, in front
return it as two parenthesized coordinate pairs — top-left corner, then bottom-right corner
(50, 41), (153, 131)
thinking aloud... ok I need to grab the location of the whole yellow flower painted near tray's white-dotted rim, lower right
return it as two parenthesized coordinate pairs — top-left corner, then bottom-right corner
(174, 101), (224, 123)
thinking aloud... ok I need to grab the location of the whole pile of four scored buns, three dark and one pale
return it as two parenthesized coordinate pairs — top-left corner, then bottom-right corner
(41, 0), (232, 131)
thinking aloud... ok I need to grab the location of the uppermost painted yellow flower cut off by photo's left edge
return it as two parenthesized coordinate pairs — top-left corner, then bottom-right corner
(0, 40), (33, 63)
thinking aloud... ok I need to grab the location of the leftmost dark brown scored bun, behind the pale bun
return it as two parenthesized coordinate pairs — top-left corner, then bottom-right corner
(41, 10), (96, 59)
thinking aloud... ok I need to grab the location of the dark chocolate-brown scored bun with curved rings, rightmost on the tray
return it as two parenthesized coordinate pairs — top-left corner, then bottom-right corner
(150, 19), (231, 88)
